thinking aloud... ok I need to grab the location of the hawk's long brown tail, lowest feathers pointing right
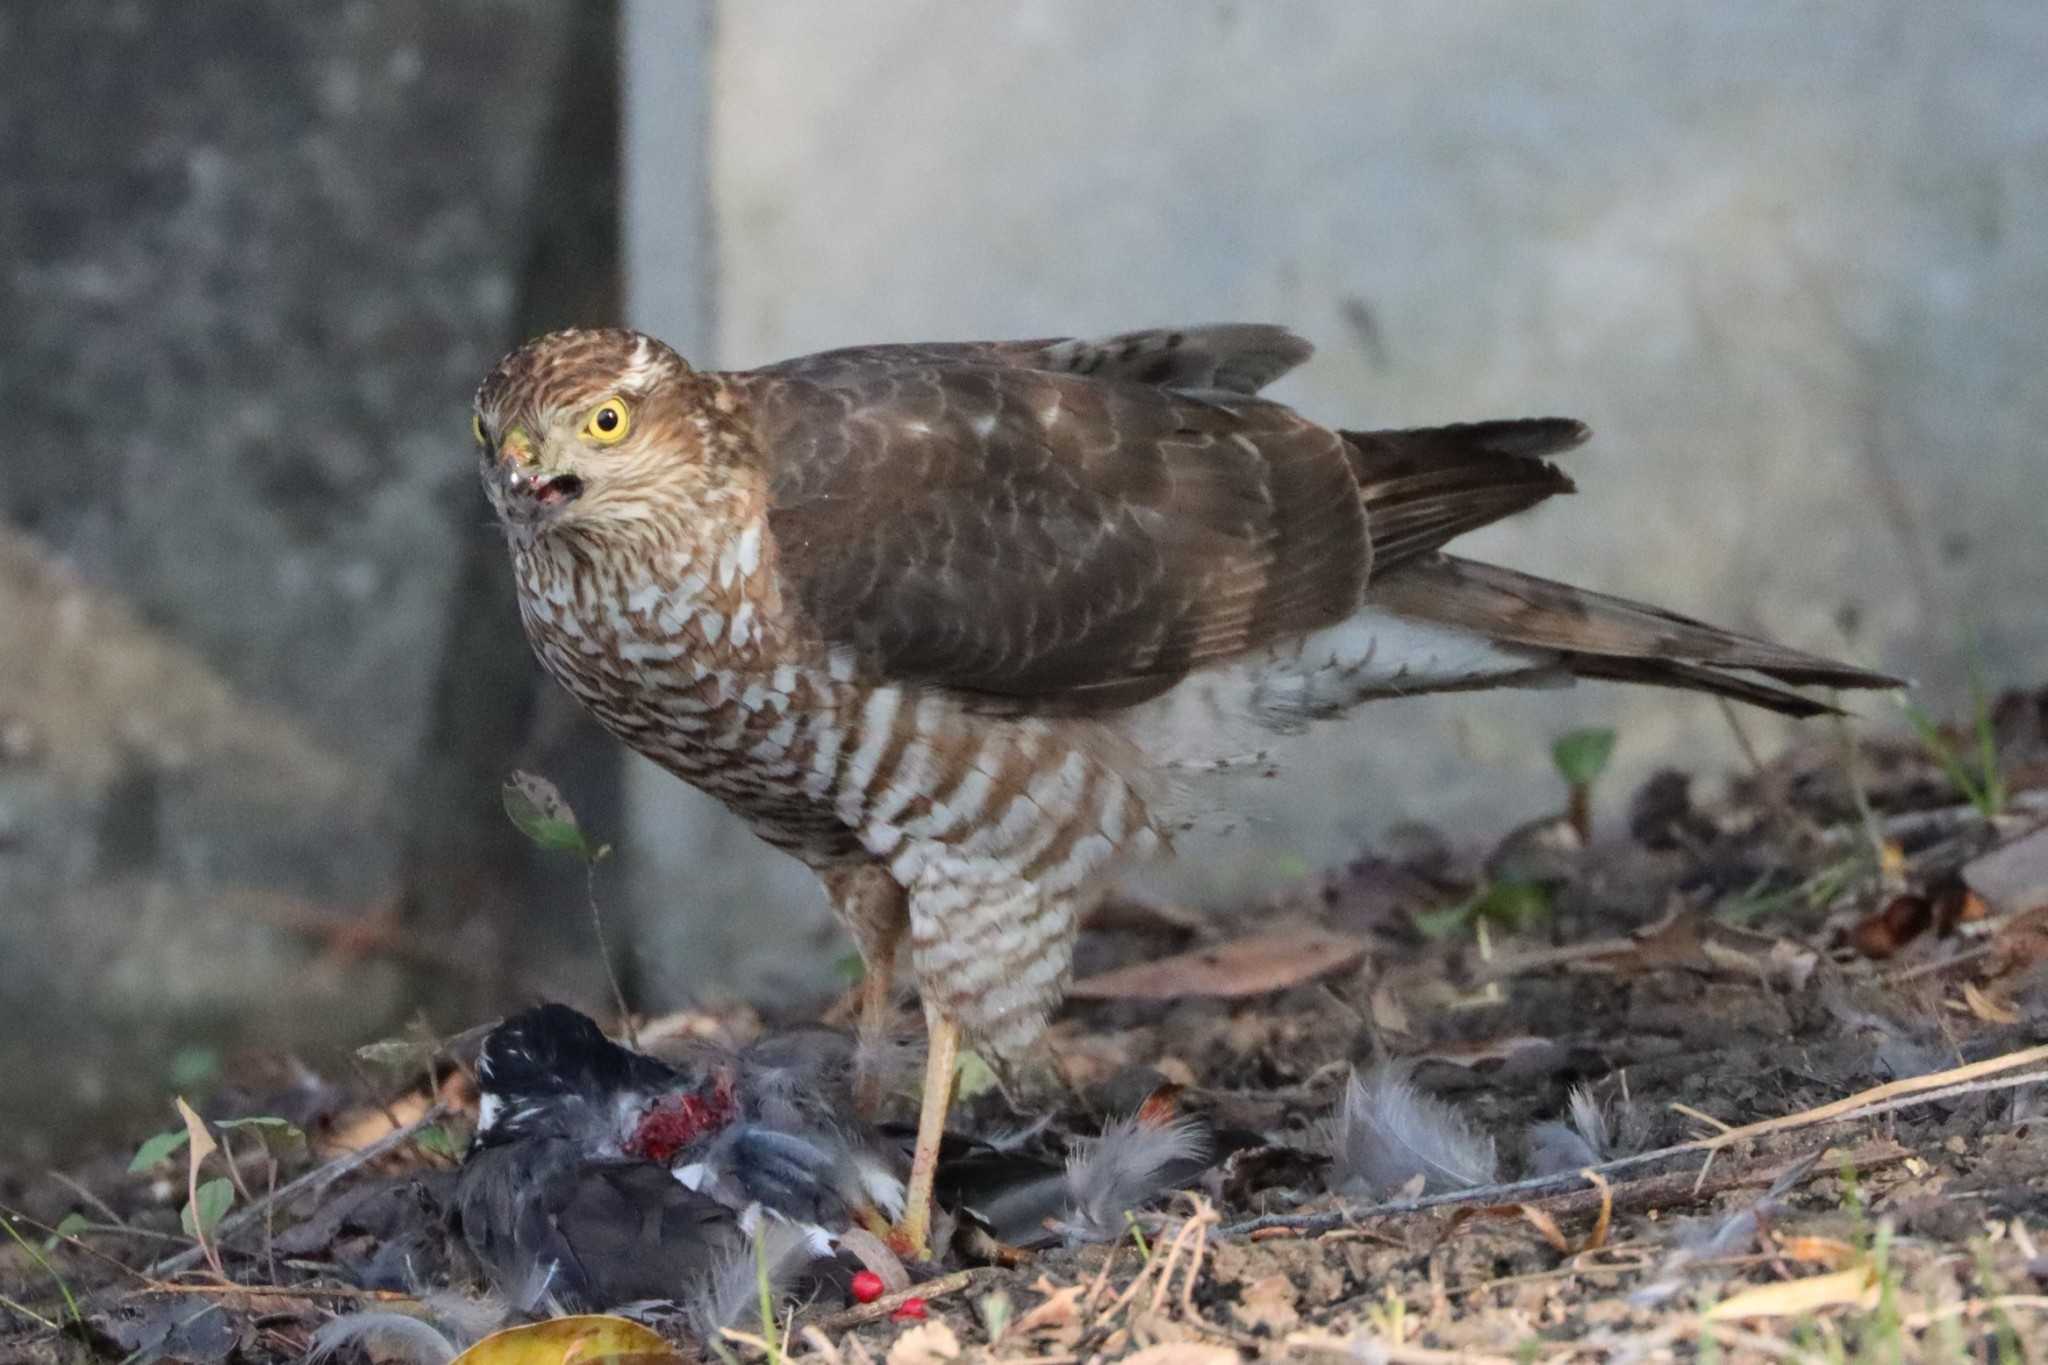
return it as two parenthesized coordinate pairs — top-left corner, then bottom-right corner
(1366, 555), (1905, 716)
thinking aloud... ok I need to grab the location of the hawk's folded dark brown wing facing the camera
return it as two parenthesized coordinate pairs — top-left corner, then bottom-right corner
(735, 337), (1370, 706)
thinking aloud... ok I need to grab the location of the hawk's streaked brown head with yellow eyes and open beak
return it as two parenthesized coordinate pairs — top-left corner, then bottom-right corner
(473, 327), (698, 536)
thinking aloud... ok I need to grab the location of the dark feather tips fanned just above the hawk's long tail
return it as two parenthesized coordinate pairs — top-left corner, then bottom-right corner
(1341, 417), (1589, 575)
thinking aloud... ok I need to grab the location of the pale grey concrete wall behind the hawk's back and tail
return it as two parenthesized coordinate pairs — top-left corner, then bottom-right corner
(633, 0), (2048, 994)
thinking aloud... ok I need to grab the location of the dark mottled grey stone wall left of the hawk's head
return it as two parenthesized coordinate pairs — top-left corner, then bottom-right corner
(0, 0), (616, 1144)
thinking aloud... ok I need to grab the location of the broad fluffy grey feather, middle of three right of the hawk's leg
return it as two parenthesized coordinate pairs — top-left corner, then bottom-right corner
(1329, 1064), (1499, 1199)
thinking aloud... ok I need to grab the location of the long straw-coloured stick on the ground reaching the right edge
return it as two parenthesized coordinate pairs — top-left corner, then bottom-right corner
(1223, 1044), (2048, 1236)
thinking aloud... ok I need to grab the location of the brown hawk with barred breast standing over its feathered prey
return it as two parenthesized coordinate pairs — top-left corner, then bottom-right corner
(475, 325), (1896, 1248)
